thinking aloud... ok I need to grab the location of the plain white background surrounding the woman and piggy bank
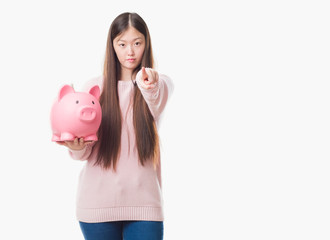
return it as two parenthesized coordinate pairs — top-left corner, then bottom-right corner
(0, 0), (330, 240)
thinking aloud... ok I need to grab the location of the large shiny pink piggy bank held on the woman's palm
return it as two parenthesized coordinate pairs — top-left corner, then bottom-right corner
(50, 85), (102, 141)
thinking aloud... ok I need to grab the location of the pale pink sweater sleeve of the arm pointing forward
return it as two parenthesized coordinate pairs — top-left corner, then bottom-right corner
(136, 74), (174, 120)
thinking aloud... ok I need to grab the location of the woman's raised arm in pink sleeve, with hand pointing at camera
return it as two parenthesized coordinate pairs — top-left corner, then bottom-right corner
(136, 68), (174, 120)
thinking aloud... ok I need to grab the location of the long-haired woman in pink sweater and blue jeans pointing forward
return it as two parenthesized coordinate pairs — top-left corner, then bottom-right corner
(60, 13), (173, 240)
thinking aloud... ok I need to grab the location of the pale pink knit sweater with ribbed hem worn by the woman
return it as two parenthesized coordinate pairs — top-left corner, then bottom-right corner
(69, 74), (173, 222)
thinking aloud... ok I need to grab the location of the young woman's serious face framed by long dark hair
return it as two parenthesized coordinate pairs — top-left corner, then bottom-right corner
(113, 26), (145, 71)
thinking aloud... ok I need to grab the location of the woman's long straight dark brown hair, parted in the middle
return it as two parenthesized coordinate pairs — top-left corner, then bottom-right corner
(96, 12), (159, 169)
